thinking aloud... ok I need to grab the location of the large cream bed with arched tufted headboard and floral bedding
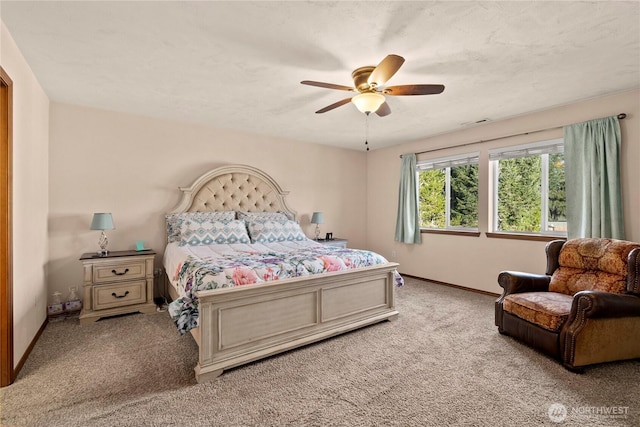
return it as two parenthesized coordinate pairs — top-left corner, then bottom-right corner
(164, 165), (402, 382)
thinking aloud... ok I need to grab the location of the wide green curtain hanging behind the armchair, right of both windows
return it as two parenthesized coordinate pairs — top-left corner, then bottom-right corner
(564, 116), (624, 239)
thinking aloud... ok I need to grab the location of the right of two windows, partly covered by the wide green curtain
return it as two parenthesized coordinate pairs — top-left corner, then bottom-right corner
(489, 139), (567, 236)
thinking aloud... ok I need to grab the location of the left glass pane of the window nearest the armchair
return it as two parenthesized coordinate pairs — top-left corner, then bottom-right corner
(497, 156), (542, 233)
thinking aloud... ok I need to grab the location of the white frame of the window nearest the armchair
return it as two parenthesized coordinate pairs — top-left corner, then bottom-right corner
(489, 138), (567, 237)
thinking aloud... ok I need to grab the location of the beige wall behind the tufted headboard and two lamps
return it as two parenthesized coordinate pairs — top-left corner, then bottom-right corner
(48, 103), (366, 295)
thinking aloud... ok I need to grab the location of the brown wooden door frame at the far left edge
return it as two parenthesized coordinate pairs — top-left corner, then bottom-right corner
(0, 67), (15, 387)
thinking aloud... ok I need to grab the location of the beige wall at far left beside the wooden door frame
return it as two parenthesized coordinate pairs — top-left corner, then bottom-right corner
(0, 23), (49, 364)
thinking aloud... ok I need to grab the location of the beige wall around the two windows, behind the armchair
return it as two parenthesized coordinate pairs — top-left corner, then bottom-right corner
(367, 90), (640, 293)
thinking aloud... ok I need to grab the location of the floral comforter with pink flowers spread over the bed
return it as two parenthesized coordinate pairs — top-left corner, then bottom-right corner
(169, 245), (403, 334)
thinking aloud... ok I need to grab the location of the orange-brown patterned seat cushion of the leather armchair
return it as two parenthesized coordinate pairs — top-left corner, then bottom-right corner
(503, 292), (573, 332)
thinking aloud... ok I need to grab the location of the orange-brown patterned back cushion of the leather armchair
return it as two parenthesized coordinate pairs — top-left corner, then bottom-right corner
(549, 238), (640, 295)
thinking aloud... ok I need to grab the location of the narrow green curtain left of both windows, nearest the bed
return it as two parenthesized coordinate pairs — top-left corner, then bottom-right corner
(396, 153), (422, 244)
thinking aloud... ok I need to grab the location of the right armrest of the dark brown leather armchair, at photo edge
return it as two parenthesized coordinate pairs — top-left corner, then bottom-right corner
(567, 291), (640, 322)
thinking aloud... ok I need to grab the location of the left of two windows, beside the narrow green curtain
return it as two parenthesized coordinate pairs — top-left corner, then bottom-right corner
(416, 153), (479, 230)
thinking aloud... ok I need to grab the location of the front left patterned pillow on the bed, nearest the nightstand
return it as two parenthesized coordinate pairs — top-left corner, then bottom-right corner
(180, 219), (250, 246)
